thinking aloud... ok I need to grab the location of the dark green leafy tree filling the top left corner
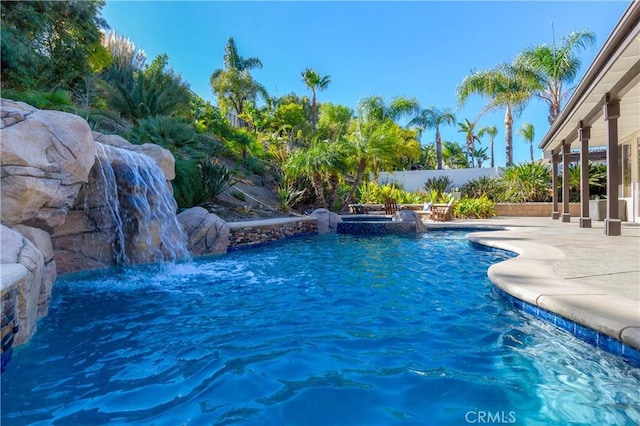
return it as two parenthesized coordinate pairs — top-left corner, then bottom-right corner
(0, 0), (107, 96)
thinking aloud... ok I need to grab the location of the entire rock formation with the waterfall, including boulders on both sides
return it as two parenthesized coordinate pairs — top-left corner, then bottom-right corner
(0, 99), (209, 344)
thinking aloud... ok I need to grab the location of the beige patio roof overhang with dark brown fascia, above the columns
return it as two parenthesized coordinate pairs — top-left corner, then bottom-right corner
(539, 0), (640, 153)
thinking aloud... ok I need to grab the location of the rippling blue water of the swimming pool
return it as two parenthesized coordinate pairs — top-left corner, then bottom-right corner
(1, 231), (640, 426)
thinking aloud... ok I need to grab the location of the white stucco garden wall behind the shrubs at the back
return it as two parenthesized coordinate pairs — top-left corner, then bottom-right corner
(378, 167), (502, 192)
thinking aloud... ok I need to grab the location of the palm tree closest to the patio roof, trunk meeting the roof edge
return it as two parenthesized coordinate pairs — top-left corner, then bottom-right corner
(515, 31), (596, 124)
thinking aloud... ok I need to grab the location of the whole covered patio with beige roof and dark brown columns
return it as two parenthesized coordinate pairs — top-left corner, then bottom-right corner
(539, 1), (640, 236)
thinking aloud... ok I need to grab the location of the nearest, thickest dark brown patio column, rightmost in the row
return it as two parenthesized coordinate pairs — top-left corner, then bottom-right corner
(604, 93), (622, 236)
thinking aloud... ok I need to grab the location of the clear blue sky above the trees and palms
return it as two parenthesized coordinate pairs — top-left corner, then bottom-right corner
(102, 0), (629, 166)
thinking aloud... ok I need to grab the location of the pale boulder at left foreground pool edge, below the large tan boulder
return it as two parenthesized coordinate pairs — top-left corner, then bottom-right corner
(0, 225), (44, 345)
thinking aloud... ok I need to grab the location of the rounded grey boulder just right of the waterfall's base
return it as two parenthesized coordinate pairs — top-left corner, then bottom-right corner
(178, 207), (230, 256)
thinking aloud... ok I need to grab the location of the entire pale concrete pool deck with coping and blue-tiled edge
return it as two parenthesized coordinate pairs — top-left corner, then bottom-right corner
(462, 218), (640, 356)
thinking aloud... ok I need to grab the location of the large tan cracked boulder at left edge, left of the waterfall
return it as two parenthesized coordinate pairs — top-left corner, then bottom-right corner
(0, 99), (95, 232)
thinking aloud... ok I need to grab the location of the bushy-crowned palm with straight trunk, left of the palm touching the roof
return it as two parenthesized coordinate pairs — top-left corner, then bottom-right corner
(456, 64), (539, 166)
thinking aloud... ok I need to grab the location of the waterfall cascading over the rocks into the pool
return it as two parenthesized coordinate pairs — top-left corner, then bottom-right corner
(84, 143), (189, 265)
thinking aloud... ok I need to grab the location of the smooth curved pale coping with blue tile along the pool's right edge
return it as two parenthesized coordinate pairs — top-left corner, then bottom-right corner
(464, 223), (640, 365)
